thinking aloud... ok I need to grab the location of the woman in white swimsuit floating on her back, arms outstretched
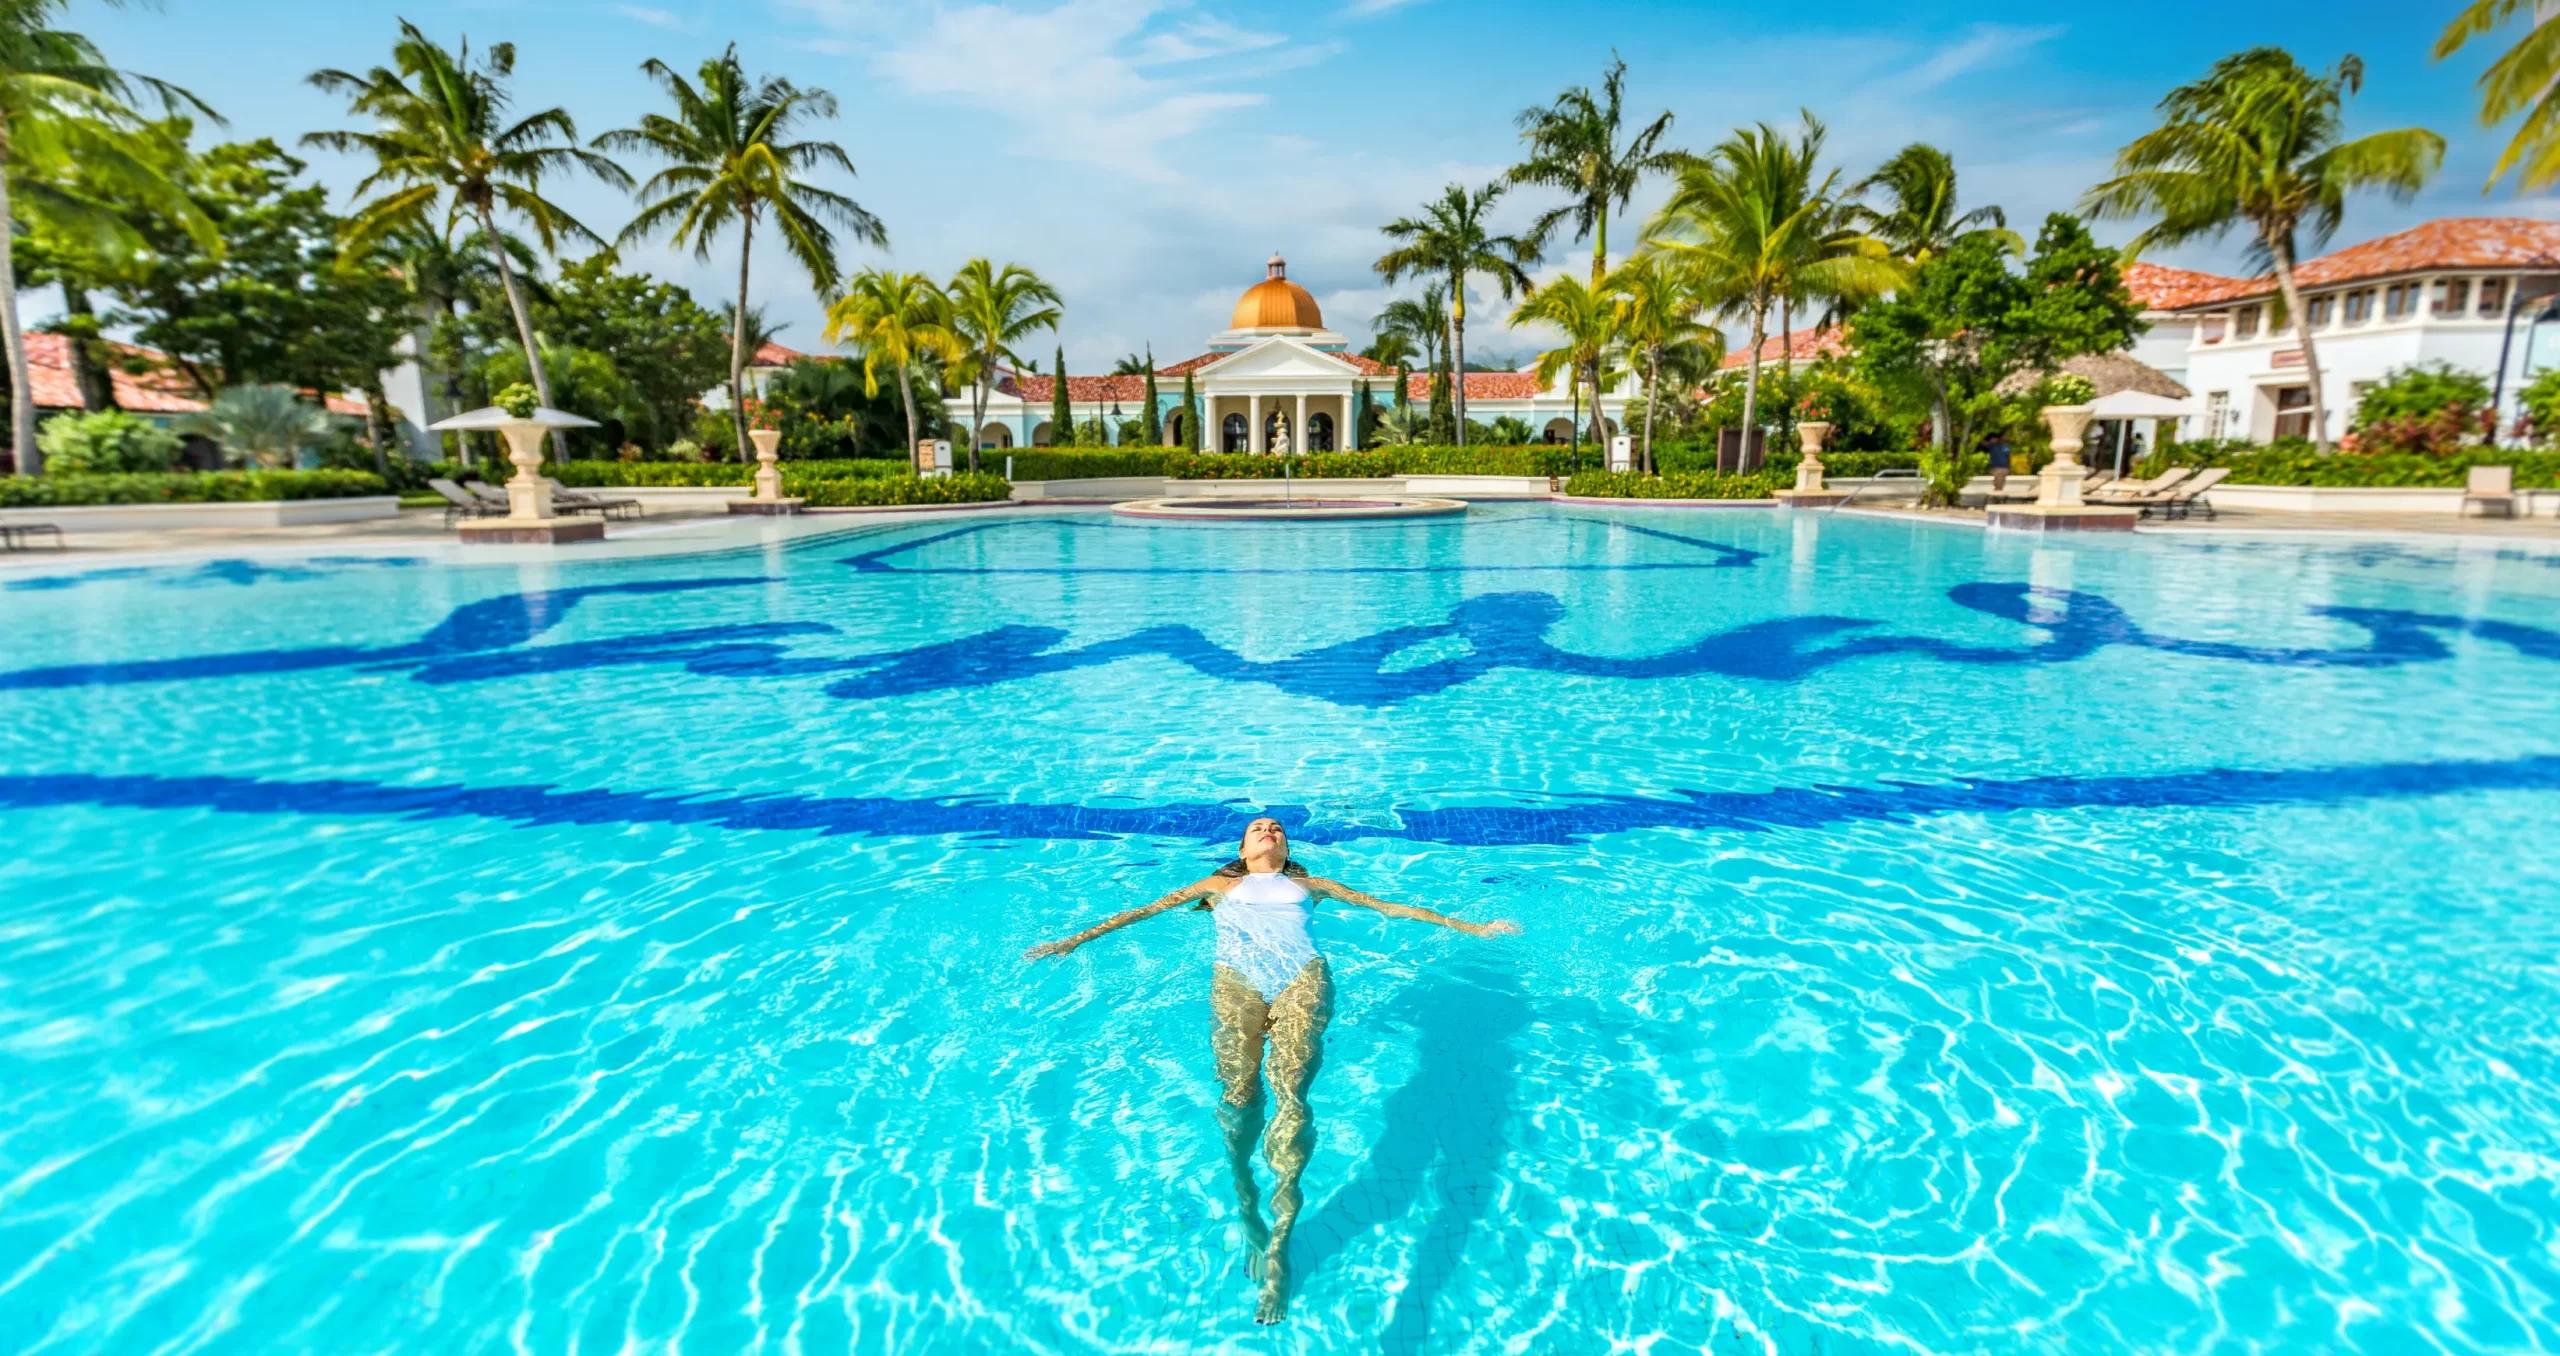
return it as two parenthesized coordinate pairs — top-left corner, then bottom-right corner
(1024, 819), (1521, 1323)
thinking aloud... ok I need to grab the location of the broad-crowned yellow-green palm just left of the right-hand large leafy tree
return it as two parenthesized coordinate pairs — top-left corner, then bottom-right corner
(1646, 113), (1902, 448)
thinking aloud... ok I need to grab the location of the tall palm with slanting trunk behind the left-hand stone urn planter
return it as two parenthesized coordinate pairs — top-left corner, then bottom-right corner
(302, 20), (630, 458)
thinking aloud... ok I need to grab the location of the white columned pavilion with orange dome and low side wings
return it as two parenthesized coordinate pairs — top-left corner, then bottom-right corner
(955, 253), (1626, 453)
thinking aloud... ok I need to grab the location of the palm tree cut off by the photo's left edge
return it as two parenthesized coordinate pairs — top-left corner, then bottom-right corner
(0, 0), (223, 476)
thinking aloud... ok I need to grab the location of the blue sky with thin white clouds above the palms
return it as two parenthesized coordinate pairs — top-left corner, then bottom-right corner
(74, 0), (2560, 371)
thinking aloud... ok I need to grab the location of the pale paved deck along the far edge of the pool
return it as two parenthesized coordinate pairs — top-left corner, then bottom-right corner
(0, 499), (2560, 571)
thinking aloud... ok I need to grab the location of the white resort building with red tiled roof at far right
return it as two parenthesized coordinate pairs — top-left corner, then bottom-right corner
(2125, 217), (2560, 443)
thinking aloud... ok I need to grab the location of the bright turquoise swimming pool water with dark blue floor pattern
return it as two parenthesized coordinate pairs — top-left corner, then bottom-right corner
(0, 507), (2560, 1353)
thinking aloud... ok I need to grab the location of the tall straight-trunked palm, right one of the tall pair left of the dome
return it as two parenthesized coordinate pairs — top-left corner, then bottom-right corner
(596, 43), (888, 461)
